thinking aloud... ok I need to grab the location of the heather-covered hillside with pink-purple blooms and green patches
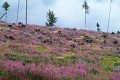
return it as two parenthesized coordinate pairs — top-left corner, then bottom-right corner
(0, 21), (120, 80)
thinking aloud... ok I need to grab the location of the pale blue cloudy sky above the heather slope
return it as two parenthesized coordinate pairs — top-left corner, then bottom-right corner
(0, 0), (120, 32)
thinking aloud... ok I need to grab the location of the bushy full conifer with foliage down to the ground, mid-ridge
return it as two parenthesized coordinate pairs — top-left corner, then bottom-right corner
(46, 10), (57, 26)
